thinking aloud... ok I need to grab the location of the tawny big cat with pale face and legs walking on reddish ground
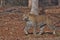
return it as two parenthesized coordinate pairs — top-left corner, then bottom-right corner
(23, 13), (56, 35)
